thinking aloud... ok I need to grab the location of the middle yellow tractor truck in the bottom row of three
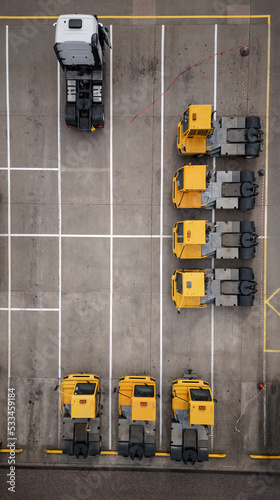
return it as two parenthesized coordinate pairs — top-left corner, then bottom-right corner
(114, 376), (156, 460)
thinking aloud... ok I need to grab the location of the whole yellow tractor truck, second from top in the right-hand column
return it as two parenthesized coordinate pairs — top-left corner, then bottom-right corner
(172, 163), (258, 210)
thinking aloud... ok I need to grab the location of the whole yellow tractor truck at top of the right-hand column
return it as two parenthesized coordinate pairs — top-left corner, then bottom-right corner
(177, 104), (263, 158)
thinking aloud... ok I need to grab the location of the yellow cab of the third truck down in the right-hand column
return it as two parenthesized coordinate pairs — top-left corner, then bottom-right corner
(172, 220), (207, 259)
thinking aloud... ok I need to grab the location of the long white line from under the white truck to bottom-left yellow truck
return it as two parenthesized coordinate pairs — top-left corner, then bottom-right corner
(57, 58), (61, 446)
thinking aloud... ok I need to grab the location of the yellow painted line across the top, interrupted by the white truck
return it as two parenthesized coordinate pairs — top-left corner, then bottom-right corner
(0, 14), (270, 24)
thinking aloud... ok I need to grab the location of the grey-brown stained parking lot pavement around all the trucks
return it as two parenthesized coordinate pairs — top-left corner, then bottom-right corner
(0, 0), (280, 498)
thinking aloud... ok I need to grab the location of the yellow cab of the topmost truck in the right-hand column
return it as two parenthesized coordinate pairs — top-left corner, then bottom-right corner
(177, 104), (213, 155)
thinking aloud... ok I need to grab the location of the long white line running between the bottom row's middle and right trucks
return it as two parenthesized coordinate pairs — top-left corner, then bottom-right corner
(159, 25), (165, 449)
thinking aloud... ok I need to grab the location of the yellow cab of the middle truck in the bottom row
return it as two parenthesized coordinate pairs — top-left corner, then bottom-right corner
(119, 376), (156, 422)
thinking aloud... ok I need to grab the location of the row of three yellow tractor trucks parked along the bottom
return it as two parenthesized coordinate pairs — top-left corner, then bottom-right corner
(55, 372), (214, 465)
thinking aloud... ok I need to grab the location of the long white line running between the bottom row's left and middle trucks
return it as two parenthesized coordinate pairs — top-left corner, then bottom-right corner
(109, 25), (114, 450)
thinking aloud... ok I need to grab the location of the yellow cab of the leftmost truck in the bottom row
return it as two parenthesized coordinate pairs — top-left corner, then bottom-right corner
(59, 374), (100, 419)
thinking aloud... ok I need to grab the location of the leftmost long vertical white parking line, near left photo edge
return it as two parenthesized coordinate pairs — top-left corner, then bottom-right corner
(6, 26), (12, 389)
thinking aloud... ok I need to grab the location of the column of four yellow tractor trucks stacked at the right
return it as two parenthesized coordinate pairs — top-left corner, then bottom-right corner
(172, 105), (263, 312)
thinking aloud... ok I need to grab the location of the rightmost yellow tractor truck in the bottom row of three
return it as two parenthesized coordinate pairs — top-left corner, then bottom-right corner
(170, 373), (215, 465)
